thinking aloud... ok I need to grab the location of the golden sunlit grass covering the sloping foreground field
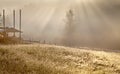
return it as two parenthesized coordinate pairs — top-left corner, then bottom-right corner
(0, 44), (120, 74)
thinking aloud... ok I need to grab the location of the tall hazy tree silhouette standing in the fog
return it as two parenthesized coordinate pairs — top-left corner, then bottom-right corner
(64, 9), (75, 46)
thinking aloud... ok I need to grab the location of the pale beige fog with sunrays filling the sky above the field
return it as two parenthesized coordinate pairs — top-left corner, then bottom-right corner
(0, 0), (120, 48)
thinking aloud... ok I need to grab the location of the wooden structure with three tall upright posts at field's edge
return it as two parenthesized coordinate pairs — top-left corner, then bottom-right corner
(0, 10), (22, 39)
